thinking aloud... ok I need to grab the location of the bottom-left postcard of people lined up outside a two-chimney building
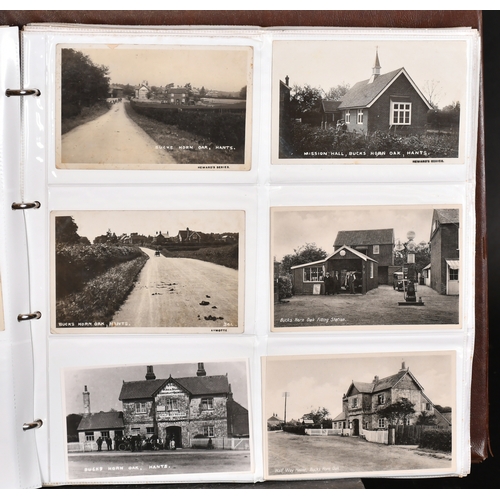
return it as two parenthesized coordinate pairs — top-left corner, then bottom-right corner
(62, 360), (252, 482)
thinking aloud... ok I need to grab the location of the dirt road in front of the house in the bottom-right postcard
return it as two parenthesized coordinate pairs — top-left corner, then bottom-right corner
(267, 431), (451, 476)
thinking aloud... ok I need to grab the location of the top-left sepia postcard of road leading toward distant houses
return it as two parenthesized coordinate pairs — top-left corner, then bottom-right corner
(56, 45), (253, 171)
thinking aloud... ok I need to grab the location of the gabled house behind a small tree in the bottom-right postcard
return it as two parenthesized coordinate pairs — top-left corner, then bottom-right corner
(338, 362), (451, 436)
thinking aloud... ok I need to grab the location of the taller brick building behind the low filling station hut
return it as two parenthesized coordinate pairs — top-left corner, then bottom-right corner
(333, 229), (394, 285)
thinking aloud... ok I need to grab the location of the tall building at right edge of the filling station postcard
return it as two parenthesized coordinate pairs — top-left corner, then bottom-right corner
(430, 208), (460, 295)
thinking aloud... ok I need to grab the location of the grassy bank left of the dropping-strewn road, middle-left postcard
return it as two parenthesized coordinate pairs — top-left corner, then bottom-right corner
(56, 254), (149, 327)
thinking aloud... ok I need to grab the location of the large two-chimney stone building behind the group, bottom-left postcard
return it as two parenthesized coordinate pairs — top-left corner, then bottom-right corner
(119, 363), (249, 448)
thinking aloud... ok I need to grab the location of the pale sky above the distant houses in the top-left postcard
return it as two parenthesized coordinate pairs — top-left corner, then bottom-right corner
(61, 45), (252, 92)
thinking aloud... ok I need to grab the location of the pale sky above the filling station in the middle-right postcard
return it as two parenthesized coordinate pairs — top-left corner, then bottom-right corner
(271, 206), (460, 261)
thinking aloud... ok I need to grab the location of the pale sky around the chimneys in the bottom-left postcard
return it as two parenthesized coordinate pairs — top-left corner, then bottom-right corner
(64, 361), (248, 415)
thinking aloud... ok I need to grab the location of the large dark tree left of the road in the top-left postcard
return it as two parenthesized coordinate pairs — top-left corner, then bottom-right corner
(61, 49), (109, 118)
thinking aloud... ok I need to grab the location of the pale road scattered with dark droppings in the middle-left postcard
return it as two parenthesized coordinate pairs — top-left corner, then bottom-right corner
(113, 248), (238, 328)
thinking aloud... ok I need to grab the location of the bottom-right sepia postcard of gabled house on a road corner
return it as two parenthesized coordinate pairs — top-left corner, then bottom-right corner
(262, 351), (457, 480)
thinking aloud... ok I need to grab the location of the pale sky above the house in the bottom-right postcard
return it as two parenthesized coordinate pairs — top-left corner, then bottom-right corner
(264, 353), (455, 420)
